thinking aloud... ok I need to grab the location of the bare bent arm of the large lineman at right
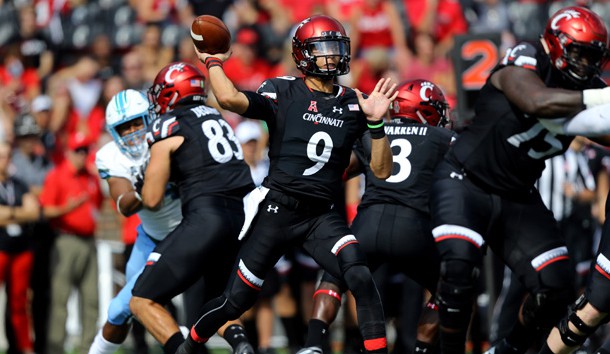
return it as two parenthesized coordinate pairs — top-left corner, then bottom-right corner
(491, 66), (583, 118)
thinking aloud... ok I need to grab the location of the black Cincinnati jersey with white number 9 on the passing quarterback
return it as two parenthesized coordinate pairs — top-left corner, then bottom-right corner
(244, 76), (367, 201)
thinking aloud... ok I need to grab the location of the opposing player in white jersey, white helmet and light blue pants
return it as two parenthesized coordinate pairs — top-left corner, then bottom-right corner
(89, 89), (182, 354)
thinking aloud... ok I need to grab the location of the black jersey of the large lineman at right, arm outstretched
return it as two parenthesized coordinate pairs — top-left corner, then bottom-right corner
(448, 43), (605, 195)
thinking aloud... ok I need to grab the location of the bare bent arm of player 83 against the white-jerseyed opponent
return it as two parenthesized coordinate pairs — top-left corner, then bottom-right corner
(142, 136), (184, 210)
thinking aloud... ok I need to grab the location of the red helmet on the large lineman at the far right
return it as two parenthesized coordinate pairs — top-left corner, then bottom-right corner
(542, 6), (608, 84)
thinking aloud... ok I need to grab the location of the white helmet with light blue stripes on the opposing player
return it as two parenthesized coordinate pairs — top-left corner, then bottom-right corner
(106, 89), (150, 159)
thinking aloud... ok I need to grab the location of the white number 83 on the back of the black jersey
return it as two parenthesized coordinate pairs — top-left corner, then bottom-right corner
(201, 119), (244, 163)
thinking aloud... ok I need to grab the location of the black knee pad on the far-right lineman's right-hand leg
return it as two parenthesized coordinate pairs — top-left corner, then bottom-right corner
(521, 288), (574, 330)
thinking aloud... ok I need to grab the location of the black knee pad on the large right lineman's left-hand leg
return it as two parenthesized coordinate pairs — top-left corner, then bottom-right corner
(437, 259), (479, 330)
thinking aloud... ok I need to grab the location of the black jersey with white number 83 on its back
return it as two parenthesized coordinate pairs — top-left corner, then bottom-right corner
(146, 105), (254, 206)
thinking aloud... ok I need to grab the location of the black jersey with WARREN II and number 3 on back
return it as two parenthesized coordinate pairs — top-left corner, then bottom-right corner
(354, 118), (456, 214)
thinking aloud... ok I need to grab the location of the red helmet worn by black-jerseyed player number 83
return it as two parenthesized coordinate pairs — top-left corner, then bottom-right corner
(148, 62), (206, 114)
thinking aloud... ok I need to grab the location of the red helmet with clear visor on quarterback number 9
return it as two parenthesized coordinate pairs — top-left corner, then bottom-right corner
(292, 15), (350, 77)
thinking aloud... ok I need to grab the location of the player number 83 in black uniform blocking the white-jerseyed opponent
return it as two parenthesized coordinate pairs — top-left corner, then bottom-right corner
(130, 62), (254, 354)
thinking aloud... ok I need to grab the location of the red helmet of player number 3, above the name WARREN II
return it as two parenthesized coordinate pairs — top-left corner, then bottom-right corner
(390, 80), (449, 127)
